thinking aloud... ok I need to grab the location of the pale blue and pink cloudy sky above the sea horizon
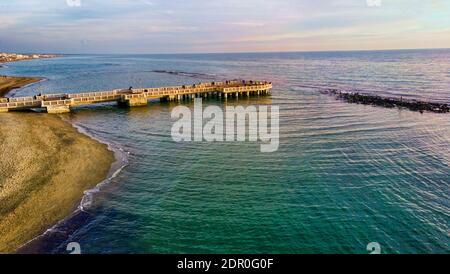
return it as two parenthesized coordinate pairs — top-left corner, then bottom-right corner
(0, 0), (450, 53)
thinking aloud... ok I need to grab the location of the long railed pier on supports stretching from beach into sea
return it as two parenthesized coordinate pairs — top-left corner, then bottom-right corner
(0, 80), (272, 113)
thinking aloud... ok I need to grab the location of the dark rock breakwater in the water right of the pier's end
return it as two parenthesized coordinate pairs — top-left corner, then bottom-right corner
(321, 89), (450, 113)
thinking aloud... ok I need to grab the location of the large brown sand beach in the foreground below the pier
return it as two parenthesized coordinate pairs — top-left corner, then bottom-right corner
(0, 113), (114, 253)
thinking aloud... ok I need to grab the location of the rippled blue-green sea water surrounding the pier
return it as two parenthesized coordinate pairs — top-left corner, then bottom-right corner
(1, 50), (450, 253)
